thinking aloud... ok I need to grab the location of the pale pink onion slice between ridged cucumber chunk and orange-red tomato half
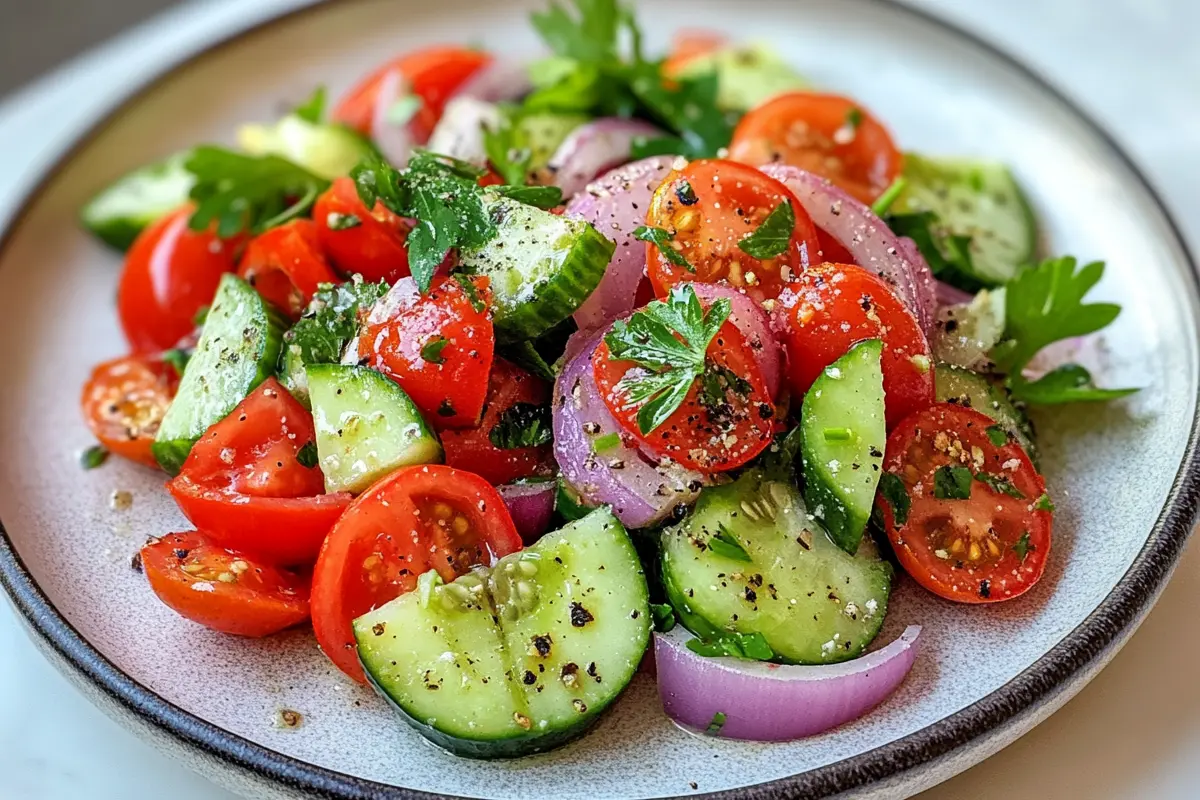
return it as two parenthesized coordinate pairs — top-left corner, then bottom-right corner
(564, 156), (674, 331)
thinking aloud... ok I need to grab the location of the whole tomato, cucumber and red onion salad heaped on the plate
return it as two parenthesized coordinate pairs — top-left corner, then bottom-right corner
(75, 0), (1134, 758)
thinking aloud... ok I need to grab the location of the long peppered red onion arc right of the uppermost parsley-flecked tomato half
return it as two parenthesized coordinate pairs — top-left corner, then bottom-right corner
(761, 164), (936, 335)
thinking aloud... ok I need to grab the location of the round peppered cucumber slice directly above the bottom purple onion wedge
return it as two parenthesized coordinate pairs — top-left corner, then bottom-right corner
(661, 469), (892, 663)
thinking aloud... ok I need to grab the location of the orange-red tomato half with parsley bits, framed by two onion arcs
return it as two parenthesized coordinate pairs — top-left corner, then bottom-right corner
(646, 158), (818, 302)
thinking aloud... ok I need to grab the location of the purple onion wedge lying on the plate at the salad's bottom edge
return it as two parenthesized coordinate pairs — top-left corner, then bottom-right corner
(654, 625), (920, 741)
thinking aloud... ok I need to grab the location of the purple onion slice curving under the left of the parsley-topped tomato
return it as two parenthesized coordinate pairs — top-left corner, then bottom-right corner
(553, 331), (703, 528)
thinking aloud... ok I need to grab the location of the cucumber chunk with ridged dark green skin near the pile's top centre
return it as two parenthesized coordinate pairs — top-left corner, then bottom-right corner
(458, 196), (617, 344)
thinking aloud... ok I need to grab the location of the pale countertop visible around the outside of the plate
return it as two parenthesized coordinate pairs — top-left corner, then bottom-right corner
(0, 0), (1200, 800)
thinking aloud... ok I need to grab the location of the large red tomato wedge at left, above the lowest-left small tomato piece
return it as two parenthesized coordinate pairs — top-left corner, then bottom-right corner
(167, 378), (350, 565)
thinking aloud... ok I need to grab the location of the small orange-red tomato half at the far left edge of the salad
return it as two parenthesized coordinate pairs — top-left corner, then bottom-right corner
(79, 355), (179, 469)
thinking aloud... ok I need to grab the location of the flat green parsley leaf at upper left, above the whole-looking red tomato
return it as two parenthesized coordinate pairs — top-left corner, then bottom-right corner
(184, 145), (329, 239)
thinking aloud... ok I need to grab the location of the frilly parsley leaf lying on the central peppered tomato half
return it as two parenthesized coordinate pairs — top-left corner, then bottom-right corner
(605, 284), (730, 433)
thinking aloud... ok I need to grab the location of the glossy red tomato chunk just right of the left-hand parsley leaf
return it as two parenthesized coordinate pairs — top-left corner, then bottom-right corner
(312, 178), (412, 284)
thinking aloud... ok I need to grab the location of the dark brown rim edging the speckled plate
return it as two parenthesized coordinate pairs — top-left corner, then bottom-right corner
(0, 0), (1200, 800)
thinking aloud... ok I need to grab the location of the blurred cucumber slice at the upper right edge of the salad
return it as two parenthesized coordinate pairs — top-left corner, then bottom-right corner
(889, 152), (1038, 287)
